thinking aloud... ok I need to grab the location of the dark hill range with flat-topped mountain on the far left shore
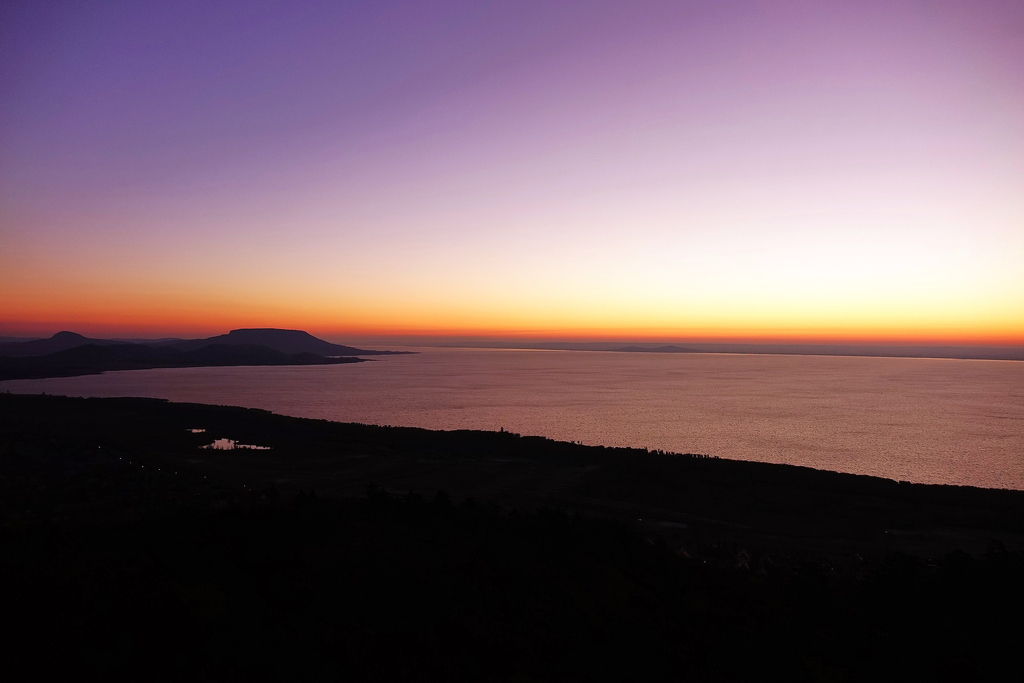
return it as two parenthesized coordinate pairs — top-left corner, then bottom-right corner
(0, 329), (403, 380)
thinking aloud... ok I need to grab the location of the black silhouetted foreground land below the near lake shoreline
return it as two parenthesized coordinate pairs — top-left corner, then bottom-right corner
(0, 394), (1024, 681)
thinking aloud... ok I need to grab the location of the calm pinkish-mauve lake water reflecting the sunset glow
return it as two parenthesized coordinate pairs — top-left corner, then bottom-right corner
(0, 349), (1024, 489)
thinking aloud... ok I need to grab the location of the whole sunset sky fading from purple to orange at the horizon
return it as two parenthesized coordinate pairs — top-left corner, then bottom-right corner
(0, 0), (1024, 344)
